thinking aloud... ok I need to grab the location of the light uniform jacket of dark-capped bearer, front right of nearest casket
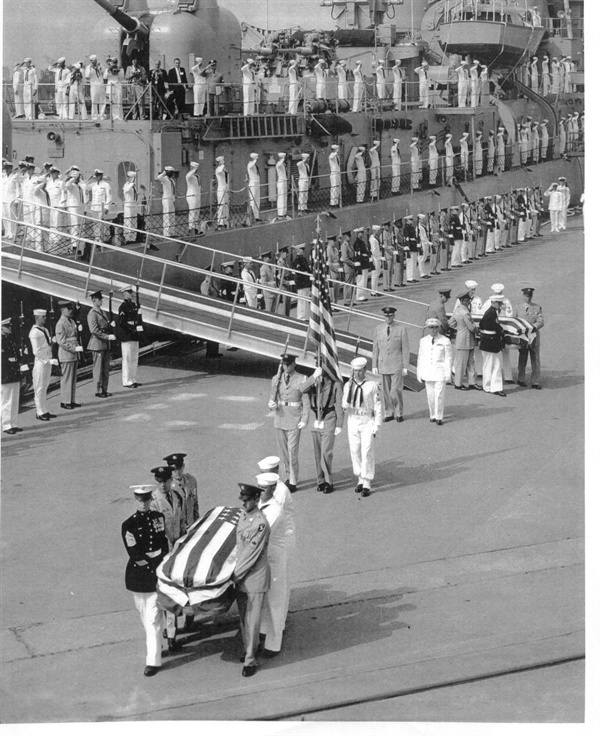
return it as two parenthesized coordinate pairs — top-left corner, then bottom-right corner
(233, 508), (271, 593)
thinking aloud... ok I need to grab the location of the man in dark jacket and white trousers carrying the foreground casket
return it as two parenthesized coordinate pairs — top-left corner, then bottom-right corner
(121, 485), (169, 677)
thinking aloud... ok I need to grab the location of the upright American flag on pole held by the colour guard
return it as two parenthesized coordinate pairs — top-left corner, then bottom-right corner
(309, 233), (342, 383)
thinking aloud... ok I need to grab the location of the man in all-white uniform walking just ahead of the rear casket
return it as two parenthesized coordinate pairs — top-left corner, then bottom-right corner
(417, 317), (452, 426)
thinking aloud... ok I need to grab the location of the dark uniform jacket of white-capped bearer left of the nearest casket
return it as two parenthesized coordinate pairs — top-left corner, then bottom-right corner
(121, 511), (169, 593)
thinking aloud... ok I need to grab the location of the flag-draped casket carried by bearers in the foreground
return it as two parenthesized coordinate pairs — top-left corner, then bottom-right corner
(156, 506), (241, 614)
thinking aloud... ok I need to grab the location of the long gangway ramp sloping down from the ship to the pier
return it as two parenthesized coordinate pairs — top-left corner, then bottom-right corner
(2, 211), (426, 390)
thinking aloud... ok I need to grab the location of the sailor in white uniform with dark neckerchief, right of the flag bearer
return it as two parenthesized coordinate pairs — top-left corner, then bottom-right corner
(342, 358), (382, 497)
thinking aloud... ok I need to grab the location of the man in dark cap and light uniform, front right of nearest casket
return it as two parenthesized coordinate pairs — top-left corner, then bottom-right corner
(231, 483), (271, 677)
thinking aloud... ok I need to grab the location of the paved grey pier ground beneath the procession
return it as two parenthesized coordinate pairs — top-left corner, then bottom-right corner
(1, 218), (585, 720)
